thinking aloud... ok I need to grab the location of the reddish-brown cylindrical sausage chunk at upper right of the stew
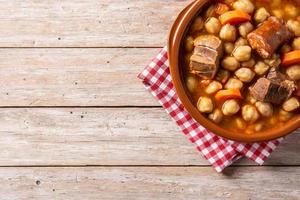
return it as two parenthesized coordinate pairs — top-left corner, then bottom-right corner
(247, 16), (293, 59)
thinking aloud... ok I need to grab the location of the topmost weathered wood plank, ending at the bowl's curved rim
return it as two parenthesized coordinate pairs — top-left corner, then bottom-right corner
(0, 0), (191, 47)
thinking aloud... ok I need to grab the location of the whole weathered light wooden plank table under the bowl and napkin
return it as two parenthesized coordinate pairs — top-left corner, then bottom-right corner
(0, 0), (300, 200)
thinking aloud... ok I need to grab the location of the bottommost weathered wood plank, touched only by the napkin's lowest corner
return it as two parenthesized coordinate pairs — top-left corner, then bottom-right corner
(0, 167), (300, 200)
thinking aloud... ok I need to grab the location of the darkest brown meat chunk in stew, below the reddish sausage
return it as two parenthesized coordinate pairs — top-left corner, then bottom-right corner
(250, 68), (296, 104)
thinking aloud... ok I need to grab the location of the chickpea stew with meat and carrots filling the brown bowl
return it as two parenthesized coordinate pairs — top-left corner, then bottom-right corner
(181, 0), (300, 134)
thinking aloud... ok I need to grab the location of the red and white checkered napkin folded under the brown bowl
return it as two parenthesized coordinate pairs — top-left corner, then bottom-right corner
(138, 48), (282, 172)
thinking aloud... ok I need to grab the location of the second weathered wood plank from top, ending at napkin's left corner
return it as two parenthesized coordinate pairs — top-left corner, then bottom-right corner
(0, 47), (159, 106)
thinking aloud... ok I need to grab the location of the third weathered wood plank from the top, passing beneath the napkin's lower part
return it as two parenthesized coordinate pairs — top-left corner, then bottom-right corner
(0, 108), (300, 166)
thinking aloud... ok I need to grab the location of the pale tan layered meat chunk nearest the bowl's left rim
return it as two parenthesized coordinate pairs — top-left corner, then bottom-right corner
(190, 35), (223, 79)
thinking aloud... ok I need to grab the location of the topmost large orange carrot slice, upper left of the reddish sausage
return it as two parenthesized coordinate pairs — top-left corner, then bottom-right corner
(220, 10), (251, 25)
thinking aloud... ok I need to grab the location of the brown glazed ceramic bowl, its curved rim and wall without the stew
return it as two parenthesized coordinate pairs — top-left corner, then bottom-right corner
(168, 0), (300, 142)
